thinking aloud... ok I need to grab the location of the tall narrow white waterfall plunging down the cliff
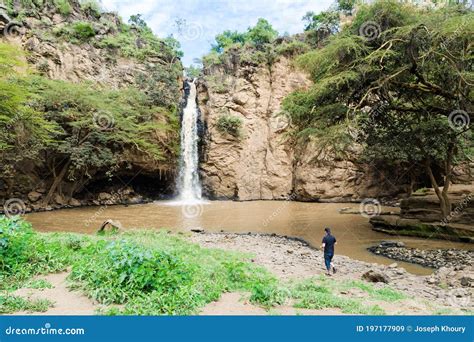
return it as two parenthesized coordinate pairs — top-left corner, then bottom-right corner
(177, 81), (202, 202)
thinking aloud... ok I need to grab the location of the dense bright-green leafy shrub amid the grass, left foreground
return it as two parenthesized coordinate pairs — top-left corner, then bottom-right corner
(71, 240), (192, 304)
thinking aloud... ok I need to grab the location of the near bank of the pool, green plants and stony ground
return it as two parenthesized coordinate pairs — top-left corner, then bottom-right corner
(0, 217), (472, 315)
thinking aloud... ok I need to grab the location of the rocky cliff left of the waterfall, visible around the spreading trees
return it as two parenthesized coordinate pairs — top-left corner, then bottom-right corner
(0, 0), (182, 209)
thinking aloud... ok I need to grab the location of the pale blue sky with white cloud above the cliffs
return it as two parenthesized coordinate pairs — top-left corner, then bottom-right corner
(101, 0), (333, 65)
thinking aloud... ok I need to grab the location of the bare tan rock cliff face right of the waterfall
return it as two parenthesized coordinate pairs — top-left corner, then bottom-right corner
(199, 56), (405, 201)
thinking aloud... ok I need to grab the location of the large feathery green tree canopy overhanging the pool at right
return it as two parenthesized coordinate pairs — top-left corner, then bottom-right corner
(283, 1), (473, 187)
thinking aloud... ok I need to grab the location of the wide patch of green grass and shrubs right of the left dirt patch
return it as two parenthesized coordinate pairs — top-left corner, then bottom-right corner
(71, 231), (275, 315)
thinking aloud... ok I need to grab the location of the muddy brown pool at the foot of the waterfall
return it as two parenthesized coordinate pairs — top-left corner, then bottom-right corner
(26, 201), (472, 274)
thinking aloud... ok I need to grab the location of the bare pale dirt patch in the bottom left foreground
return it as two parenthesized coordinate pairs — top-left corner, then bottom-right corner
(13, 272), (97, 315)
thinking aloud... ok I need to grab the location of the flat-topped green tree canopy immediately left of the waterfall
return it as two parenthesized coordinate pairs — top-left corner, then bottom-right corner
(26, 77), (180, 179)
